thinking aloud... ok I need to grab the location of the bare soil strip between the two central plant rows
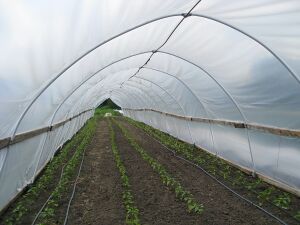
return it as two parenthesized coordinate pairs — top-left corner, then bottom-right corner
(113, 125), (199, 225)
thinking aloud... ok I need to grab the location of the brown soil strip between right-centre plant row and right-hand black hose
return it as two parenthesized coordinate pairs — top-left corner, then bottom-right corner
(118, 120), (278, 225)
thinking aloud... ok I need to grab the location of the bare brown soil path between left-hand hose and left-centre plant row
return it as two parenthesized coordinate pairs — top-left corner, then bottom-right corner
(68, 120), (125, 225)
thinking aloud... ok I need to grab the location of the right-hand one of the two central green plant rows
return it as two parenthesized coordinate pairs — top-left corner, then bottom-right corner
(114, 120), (204, 214)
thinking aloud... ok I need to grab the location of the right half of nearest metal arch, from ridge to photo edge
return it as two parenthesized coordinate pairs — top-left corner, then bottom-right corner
(189, 13), (300, 84)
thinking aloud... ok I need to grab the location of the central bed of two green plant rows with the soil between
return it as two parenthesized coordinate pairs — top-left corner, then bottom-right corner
(109, 119), (204, 225)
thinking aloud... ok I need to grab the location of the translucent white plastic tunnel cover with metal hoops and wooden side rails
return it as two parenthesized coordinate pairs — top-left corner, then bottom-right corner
(0, 0), (300, 220)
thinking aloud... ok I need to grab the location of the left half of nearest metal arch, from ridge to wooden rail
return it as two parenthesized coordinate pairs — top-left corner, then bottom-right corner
(11, 13), (184, 139)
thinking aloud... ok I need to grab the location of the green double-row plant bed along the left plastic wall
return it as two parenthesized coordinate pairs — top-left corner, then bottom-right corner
(0, 119), (96, 225)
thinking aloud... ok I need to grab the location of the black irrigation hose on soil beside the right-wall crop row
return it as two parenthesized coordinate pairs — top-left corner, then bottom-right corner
(128, 121), (288, 225)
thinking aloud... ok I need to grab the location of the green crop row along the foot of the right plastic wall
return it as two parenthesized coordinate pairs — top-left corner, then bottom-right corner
(126, 118), (300, 221)
